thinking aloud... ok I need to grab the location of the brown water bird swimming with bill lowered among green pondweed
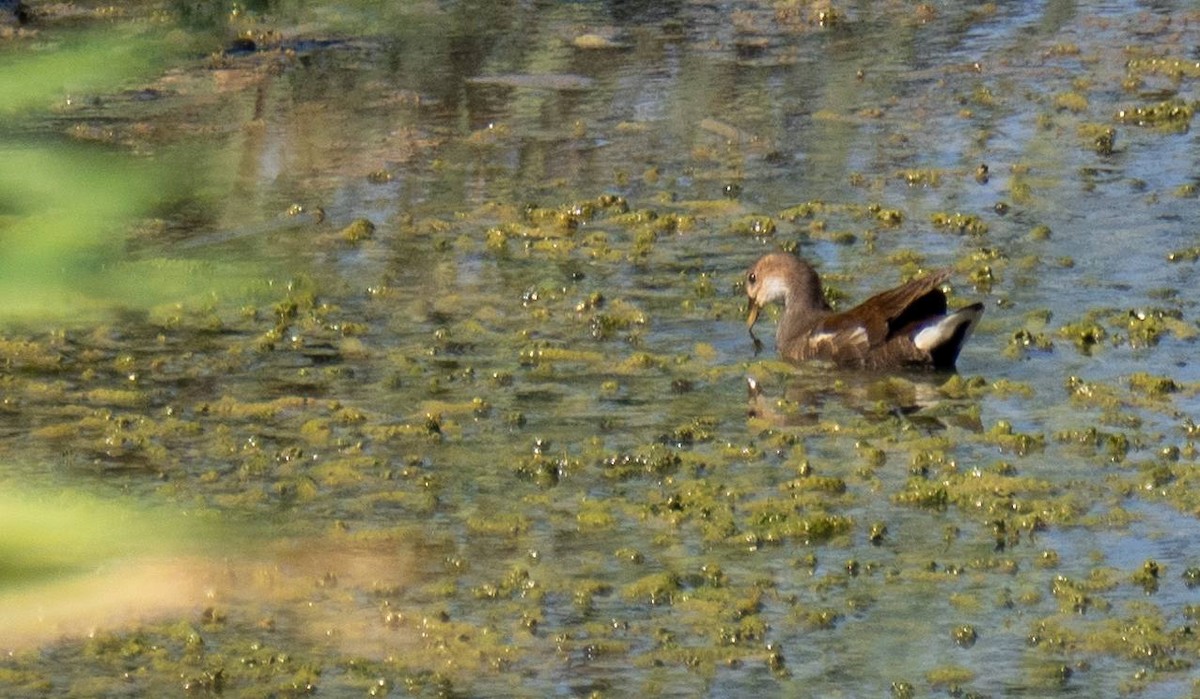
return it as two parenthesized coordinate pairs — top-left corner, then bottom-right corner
(746, 252), (983, 369)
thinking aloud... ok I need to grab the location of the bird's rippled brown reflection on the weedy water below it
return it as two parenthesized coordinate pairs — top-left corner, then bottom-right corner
(746, 369), (983, 434)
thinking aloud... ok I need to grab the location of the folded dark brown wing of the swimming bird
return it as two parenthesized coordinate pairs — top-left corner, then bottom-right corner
(816, 270), (950, 347)
